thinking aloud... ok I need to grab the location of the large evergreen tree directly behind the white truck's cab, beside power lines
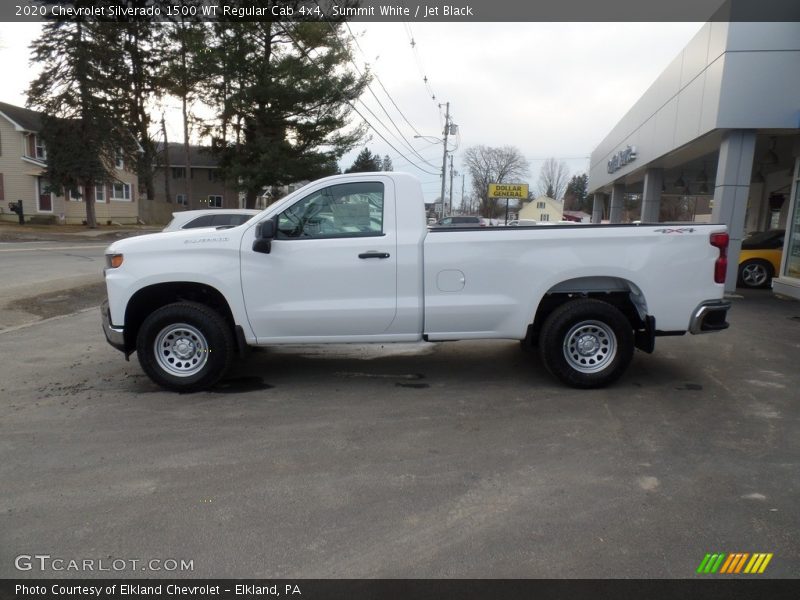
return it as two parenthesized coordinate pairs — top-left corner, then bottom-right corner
(209, 15), (368, 206)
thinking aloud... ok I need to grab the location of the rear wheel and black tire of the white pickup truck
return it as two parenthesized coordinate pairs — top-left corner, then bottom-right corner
(539, 298), (634, 389)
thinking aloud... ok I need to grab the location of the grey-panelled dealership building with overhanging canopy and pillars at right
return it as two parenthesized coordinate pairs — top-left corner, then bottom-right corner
(589, 22), (800, 299)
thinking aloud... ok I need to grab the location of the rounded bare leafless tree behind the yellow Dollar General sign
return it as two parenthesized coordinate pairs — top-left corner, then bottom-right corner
(464, 146), (530, 218)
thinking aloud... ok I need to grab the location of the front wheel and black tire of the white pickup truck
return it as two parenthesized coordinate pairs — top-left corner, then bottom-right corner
(136, 302), (235, 392)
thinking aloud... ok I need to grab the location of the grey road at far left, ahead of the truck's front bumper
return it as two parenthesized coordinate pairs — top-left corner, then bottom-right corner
(0, 240), (108, 330)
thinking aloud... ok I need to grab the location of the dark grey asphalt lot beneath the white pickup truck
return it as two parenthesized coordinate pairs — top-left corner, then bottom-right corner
(0, 291), (800, 578)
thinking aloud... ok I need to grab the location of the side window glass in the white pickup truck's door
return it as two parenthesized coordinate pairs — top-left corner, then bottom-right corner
(276, 182), (383, 240)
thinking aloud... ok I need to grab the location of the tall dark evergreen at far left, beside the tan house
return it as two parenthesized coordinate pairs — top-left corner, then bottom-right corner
(28, 11), (136, 228)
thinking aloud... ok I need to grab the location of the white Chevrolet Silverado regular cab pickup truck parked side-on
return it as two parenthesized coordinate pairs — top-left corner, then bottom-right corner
(102, 173), (730, 391)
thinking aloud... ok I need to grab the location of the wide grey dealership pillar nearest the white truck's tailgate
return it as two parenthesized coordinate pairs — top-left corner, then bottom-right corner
(711, 129), (756, 292)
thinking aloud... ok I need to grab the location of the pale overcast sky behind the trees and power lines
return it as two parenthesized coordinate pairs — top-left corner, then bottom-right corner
(0, 23), (703, 204)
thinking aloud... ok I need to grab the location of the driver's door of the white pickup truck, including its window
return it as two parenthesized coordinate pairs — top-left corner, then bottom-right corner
(241, 177), (397, 343)
